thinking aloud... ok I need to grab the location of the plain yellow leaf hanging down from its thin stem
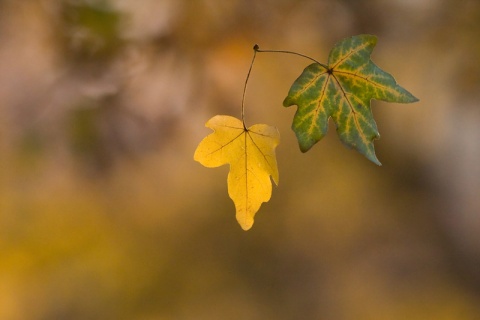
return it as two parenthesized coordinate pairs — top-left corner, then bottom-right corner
(194, 115), (280, 230)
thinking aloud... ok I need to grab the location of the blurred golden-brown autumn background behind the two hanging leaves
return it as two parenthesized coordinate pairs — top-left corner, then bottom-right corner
(0, 0), (480, 320)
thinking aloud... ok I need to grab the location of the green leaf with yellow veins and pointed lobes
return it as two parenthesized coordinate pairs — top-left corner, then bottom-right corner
(283, 35), (418, 165)
